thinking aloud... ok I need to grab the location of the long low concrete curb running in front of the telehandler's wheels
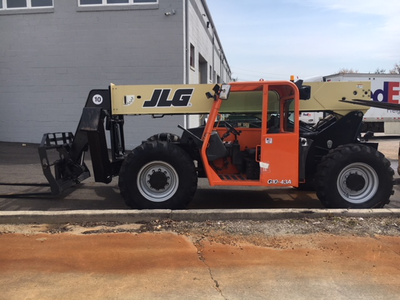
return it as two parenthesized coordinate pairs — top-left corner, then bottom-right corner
(0, 208), (400, 224)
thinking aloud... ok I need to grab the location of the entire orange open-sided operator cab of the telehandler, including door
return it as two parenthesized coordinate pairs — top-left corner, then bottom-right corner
(195, 81), (299, 186)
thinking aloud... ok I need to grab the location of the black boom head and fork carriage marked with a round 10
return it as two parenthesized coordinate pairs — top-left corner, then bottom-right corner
(38, 90), (125, 195)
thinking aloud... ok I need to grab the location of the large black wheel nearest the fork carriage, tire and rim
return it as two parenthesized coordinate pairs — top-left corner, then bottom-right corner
(118, 140), (197, 209)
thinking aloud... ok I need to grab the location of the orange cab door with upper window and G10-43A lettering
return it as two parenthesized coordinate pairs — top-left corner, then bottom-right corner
(257, 82), (299, 187)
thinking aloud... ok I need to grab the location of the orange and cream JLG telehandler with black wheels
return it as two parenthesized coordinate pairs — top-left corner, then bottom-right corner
(39, 80), (394, 209)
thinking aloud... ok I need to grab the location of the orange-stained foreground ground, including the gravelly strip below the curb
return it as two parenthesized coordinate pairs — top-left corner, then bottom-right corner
(0, 217), (400, 300)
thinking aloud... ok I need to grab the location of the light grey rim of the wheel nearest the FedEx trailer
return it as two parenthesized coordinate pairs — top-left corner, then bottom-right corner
(337, 163), (379, 204)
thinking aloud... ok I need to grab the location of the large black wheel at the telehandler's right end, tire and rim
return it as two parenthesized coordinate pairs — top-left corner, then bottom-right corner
(315, 144), (394, 208)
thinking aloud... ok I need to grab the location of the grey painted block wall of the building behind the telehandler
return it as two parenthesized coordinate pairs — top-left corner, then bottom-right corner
(0, 0), (230, 149)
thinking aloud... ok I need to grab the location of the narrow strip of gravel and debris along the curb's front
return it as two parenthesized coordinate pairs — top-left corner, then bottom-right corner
(0, 216), (400, 246)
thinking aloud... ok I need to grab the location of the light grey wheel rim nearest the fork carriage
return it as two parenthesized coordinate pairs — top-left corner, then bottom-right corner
(137, 161), (179, 202)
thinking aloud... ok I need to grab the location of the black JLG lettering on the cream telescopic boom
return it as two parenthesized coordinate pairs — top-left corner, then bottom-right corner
(143, 89), (193, 107)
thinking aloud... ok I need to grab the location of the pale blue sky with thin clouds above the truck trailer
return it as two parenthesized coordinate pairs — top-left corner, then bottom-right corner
(207, 0), (400, 81)
